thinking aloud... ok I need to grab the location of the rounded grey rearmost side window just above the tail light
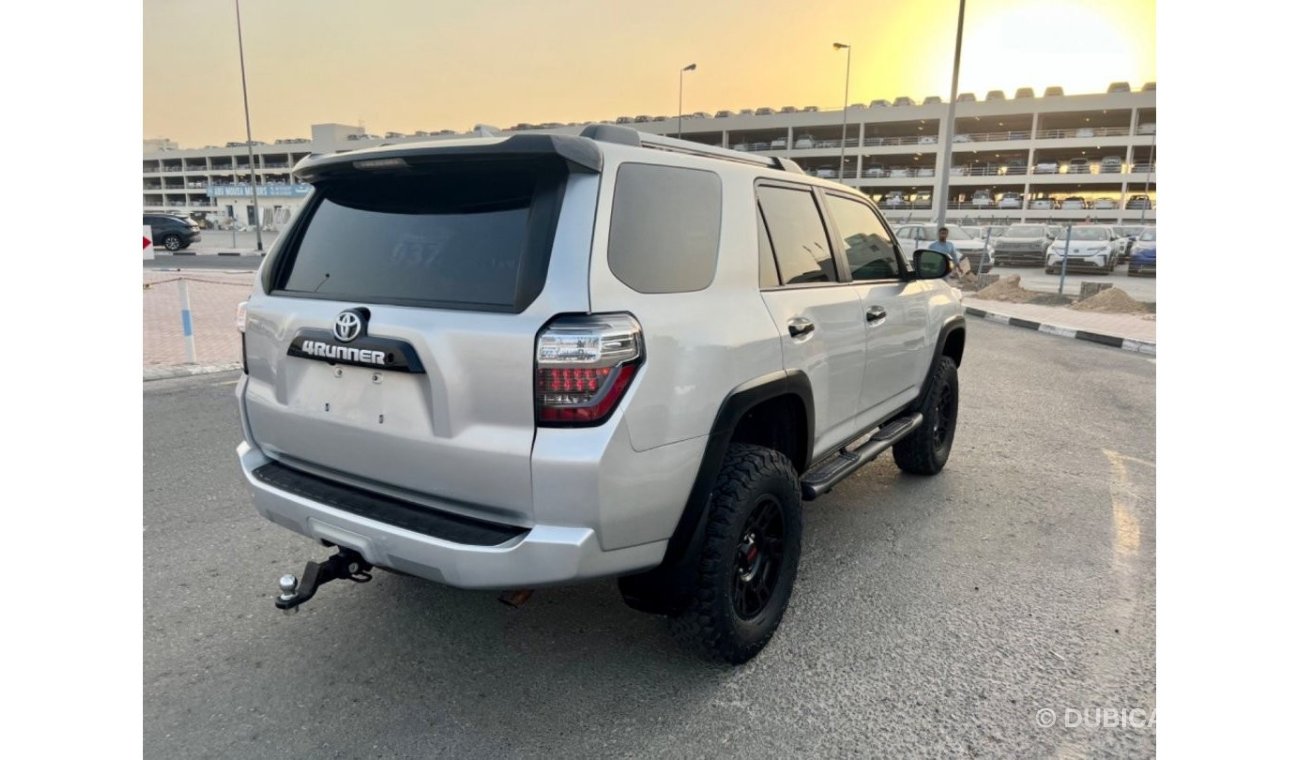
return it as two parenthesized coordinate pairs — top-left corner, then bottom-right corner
(608, 164), (723, 292)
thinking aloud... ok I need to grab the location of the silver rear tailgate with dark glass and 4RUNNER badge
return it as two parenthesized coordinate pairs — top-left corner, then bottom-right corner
(244, 156), (597, 525)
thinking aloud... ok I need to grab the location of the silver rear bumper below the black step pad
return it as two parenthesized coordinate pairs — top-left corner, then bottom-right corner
(237, 442), (668, 589)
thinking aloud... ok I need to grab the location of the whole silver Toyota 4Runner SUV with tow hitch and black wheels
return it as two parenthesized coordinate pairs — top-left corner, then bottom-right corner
(238, 125), (966, 663)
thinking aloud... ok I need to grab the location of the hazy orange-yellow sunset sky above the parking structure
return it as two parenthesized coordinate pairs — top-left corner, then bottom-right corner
(144, 0), (1156, 147)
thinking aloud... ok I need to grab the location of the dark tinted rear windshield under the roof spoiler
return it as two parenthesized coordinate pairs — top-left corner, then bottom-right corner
(277, 160), (564, 312)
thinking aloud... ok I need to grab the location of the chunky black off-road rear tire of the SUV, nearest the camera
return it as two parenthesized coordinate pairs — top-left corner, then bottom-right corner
(670, 443), (803, 665)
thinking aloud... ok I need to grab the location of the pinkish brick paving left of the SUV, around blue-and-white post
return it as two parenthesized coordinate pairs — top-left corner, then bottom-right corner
(143, 272), (254, 368)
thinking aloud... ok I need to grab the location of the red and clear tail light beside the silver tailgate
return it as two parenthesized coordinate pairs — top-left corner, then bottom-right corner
(533, 314), (645, 427)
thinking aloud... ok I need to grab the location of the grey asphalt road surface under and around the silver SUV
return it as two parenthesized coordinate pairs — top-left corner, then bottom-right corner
(144, 320), (1156, 760)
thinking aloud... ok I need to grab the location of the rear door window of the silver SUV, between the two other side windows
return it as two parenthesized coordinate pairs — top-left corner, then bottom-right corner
(758, 187), (837, 285)
